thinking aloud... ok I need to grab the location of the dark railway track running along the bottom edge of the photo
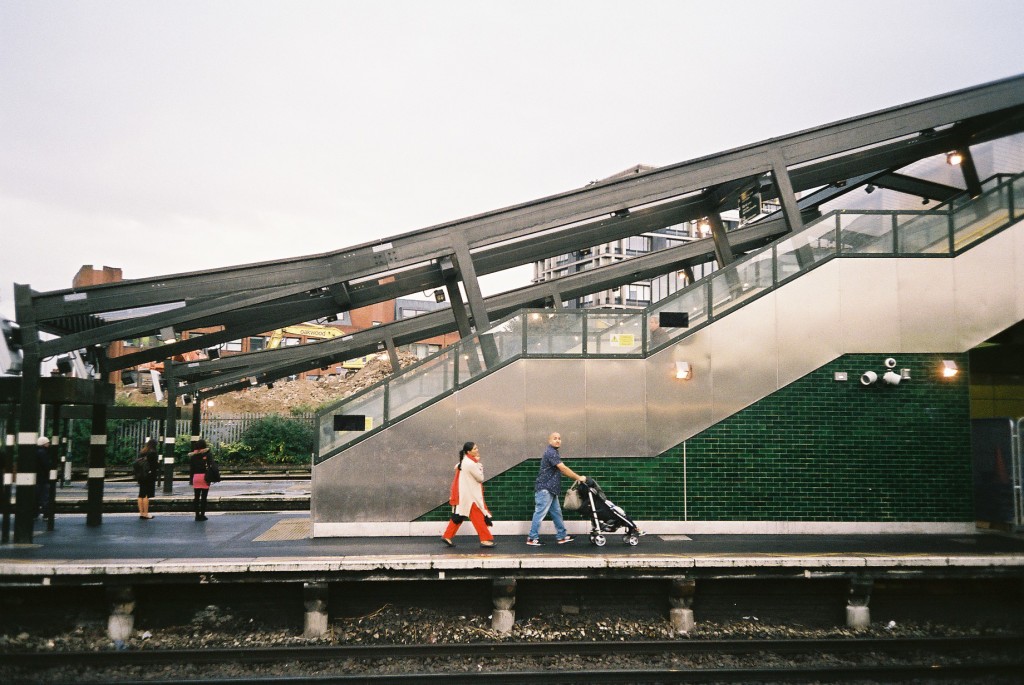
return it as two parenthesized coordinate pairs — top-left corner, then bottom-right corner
(0, 635), (1024, 684)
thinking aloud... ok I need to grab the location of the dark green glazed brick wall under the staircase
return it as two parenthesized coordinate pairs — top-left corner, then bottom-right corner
(419, 353), (973, 522)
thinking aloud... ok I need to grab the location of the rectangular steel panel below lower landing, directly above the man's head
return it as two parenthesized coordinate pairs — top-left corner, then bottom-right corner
(518, 359), (589, 458)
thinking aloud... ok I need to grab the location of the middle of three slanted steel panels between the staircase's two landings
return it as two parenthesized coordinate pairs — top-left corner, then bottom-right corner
(711, 293), (778, 422)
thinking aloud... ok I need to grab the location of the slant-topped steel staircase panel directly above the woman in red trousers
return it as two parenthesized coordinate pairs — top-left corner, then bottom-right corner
(456, 363), (528, 478)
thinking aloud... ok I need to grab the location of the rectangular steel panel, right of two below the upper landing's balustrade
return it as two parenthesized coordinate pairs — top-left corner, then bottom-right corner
(896, 259), (956, 352)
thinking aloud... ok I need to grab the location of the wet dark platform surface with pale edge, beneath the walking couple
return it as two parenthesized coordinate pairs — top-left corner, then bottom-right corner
(0, 512), (1024, 576)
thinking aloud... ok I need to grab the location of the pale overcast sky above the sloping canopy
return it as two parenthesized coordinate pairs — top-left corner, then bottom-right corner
(0, 0), (1024, 317)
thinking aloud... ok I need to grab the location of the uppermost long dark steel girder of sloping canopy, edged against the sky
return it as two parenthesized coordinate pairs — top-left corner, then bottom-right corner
(24, 77), (1024, 320)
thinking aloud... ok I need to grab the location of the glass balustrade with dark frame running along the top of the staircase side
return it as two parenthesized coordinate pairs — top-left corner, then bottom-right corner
(318, 169), (1024, 460)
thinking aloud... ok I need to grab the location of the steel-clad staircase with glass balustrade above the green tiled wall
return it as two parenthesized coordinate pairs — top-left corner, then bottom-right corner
(312, 169), (1024, 536)
